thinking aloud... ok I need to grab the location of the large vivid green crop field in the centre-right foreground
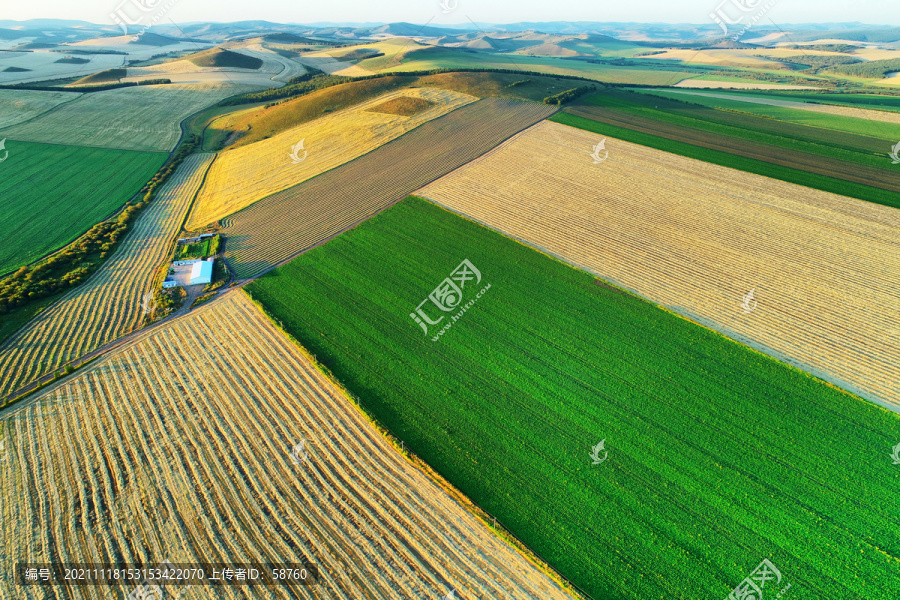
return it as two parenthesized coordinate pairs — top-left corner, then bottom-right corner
(249, 199), (900, 600)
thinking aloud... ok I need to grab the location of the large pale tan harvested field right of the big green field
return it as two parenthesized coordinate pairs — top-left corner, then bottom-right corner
(421, 123), (900, 410)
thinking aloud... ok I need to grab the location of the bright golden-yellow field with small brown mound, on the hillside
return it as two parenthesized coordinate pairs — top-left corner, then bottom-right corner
(187, 89), (476, 229)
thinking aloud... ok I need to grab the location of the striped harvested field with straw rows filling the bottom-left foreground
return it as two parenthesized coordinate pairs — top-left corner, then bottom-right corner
(0, 291), (570, 600)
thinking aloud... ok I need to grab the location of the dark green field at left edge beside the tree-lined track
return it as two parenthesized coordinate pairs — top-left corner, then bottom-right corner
(0, 140), (168, 274)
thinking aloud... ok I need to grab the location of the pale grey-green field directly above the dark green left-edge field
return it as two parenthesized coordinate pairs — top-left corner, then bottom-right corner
(3, 84), (251, 152)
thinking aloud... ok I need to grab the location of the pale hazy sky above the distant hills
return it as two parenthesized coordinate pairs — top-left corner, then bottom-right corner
(0, 0), (900, 25)
